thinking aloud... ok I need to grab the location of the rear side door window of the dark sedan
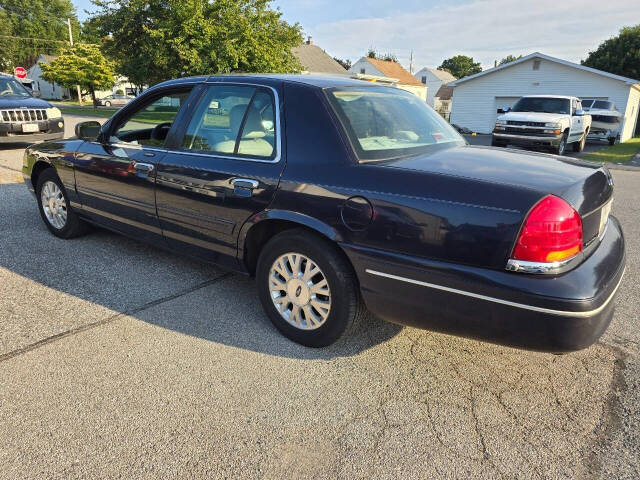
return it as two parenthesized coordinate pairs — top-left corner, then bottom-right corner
(182, 85), (276, 159)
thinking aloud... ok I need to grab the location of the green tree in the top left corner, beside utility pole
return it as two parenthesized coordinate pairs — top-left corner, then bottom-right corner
(0, 0), (80, 70)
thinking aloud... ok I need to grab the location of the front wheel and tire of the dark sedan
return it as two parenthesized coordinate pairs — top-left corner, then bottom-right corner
(36, 168), (88, 238)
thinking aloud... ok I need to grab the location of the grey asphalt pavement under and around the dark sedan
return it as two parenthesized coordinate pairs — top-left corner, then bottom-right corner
(0, 117), (640, 479)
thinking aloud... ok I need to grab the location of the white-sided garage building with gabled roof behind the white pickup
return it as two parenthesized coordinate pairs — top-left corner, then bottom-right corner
(449, 52), (640, 141)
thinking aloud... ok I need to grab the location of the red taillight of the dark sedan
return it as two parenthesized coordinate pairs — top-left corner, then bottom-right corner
(512, 195), (582, 263)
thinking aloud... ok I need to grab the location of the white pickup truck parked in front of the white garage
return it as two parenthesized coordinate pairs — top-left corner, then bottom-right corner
(491, 95), (591, 155)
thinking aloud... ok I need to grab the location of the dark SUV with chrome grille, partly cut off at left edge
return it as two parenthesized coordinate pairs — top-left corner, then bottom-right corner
(0, 75), (64, 143)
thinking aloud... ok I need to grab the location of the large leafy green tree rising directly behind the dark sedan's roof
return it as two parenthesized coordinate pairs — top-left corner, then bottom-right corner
(90, 0), (302, 86)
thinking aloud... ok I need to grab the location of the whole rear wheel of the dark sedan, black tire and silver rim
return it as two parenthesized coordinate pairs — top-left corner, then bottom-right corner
(256, 229), (363, 347)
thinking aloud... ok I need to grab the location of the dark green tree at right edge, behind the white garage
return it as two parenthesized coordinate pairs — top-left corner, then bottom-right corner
(582, 25), (640, 79)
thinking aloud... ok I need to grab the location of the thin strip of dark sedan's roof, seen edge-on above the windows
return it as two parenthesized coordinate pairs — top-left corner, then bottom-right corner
(155, 73), (384, 88)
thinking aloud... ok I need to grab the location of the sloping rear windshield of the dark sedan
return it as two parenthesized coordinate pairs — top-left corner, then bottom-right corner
(326, 87), (464, 161)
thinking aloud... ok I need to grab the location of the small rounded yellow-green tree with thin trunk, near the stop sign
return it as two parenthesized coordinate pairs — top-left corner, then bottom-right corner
(40, 43), (115, 106)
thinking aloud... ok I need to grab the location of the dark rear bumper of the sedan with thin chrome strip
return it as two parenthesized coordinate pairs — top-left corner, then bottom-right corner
(342, 217), (625, 353)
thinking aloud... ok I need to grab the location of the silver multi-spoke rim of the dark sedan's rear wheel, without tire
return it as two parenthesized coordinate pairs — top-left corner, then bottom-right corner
(269, 253), (331, 330)
